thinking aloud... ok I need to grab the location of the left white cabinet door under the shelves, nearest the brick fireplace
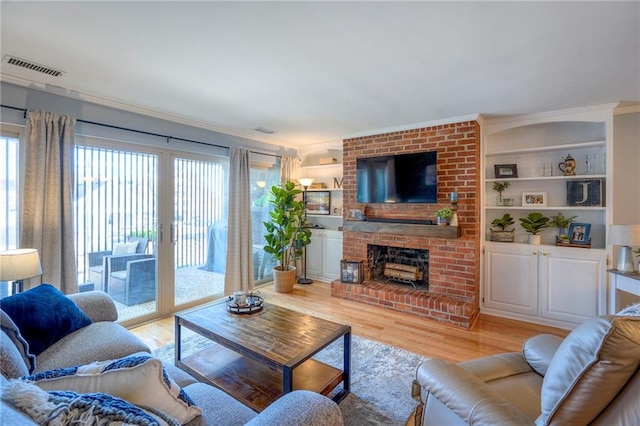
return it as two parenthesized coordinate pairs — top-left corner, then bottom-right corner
(484, 244), (538, 316)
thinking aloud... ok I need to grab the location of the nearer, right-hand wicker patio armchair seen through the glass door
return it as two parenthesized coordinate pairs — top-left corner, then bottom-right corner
(109, 255), (156, 306)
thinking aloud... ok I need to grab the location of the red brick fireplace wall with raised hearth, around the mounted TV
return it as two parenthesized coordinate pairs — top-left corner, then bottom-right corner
(331, 121), (480, 328)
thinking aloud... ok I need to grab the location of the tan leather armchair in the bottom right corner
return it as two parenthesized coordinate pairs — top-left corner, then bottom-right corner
(414, 316), (640, 426)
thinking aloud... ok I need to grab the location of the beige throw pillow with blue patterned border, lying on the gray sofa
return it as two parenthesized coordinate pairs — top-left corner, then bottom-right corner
(23, 355), (202, 424)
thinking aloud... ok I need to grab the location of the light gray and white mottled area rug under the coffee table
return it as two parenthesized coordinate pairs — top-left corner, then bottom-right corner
(153, 335), (426, 426)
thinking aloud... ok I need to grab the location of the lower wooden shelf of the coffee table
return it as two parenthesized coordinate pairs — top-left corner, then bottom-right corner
(178, 344), (344, 412)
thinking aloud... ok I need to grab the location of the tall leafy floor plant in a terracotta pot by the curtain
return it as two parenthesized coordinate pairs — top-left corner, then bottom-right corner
(263, 182), (311, 293)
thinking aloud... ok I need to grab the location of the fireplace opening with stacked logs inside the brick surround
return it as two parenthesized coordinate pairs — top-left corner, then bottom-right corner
(367, 244), (429, 291)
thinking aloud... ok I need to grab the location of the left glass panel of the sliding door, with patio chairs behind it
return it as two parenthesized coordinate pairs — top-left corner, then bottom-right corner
(74, 144), (159, 321)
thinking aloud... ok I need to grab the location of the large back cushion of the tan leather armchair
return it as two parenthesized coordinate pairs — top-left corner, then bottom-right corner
(536, 316), (640, 425)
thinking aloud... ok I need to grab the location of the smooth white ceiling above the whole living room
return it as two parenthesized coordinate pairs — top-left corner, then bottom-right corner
(0, 1), (640, 146)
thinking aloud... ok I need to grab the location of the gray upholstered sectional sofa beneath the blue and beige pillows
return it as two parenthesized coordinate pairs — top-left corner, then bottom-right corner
(0, 291), (343, 426)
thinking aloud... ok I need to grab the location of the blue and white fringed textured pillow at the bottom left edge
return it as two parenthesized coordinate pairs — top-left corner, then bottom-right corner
(2, 380), (178, 426)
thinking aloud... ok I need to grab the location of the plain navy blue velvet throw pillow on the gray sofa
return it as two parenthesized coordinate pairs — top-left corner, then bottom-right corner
(0, 284), (91, 355)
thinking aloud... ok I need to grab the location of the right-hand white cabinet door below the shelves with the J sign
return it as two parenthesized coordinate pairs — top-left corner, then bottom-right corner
(539, 247), (606, 324)
